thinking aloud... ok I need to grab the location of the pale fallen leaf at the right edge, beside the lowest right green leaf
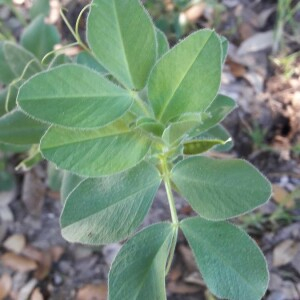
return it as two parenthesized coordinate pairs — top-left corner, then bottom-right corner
(273, 240), (300, 267)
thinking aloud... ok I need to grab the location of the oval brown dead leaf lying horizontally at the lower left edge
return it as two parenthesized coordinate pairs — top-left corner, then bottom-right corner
(1, 253), (38, 272)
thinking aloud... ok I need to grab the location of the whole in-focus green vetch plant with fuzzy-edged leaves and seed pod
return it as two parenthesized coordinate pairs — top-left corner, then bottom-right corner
(18, 0), (271, 300)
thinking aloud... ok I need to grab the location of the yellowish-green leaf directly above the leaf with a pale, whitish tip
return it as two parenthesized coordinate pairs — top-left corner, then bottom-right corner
(41, 122), (151, 177)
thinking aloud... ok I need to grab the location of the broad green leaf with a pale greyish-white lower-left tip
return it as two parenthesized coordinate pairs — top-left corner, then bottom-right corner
(61, 162), (161, 245)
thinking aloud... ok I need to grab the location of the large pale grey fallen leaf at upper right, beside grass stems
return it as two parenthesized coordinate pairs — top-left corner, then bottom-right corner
(237, 30), (274, 56)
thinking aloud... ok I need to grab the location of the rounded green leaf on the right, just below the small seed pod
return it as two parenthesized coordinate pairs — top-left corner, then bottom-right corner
(172, 156), (271, 220)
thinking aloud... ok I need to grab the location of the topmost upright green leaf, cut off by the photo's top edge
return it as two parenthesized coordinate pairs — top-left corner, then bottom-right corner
(87, 0), (156, 90)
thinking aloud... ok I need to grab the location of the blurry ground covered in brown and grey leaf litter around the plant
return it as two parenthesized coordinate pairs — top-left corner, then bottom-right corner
(0, 0), (300, 300)
